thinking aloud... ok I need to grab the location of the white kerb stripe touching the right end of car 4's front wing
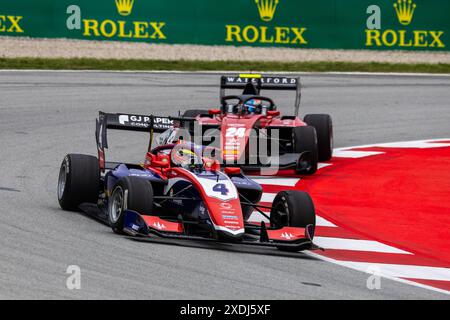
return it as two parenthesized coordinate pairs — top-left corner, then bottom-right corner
(314, 237), (412, 254)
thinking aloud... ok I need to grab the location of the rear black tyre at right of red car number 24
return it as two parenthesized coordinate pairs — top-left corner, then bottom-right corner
(303, 114), (333, 161)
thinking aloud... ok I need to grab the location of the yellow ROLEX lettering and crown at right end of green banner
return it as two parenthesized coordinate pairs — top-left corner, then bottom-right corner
(365, 0), (446, 49)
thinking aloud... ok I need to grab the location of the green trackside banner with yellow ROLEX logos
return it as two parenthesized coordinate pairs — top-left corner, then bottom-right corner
(0, 0), (450, 51)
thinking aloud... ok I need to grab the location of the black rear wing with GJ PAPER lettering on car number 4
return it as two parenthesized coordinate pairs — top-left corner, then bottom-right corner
(95, 111), (174, 171)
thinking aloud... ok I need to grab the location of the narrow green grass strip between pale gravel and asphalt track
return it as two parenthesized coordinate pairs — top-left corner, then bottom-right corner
(0, 58), (450, 73)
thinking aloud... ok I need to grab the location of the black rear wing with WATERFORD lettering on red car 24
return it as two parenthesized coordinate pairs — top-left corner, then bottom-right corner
(220, 74), (301, 116)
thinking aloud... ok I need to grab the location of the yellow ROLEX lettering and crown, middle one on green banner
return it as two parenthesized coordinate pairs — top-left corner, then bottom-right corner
(225, 0), (308, 46)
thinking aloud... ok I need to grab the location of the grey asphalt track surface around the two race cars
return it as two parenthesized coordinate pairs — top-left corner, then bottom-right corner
(0, 71), (450, 299)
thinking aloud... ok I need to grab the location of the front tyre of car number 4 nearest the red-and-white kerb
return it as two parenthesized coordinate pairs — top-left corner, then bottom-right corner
(270, 190), (316, 251)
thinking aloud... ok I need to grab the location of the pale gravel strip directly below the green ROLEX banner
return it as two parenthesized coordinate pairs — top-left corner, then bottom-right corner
(0, 37), (450, 64)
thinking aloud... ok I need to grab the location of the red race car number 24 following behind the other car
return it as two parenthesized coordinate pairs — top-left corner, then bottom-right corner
(179, 74), (333, 174)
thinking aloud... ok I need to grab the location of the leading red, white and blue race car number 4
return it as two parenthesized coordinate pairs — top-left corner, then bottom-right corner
(57, 112), (317, 251)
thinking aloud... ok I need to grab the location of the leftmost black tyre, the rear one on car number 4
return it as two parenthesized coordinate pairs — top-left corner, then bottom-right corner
(57, 154), (100, 211)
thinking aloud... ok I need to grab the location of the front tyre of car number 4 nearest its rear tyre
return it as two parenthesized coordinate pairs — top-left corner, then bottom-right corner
(108, 177), (153, 234)
